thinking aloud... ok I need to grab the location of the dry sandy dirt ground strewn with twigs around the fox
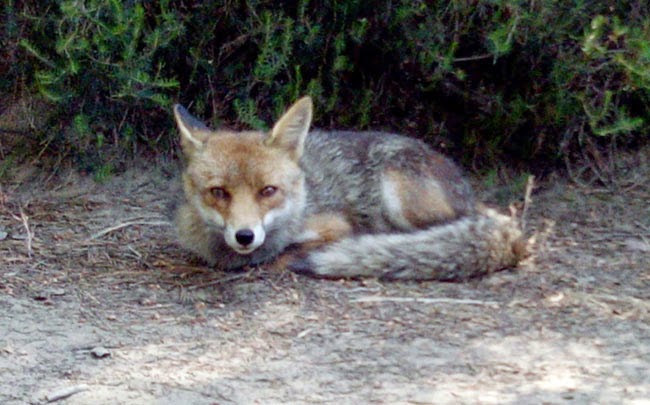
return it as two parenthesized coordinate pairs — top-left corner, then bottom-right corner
(0, 153), (650, 405)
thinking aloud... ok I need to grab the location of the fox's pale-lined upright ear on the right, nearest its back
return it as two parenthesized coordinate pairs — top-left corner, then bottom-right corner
(264, 96), (313, 160)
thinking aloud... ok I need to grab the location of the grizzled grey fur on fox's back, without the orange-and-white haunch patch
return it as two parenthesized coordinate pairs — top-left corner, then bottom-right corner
(301, 130), (475, 233)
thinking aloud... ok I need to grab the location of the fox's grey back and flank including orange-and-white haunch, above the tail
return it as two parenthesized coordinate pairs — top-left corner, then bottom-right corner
(301, 131), (475, 230)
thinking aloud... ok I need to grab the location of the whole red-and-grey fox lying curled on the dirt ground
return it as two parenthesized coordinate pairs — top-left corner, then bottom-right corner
(173, 96), (526, 281)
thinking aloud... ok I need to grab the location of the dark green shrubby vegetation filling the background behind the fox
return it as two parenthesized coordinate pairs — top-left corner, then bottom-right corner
(0, 0), (650, 183)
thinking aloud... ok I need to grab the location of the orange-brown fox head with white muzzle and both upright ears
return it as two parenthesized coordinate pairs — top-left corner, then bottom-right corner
(174, 97), (312, 255)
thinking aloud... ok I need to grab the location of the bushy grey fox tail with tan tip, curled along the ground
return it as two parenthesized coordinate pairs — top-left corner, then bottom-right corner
(289, 210), (527, 281)
